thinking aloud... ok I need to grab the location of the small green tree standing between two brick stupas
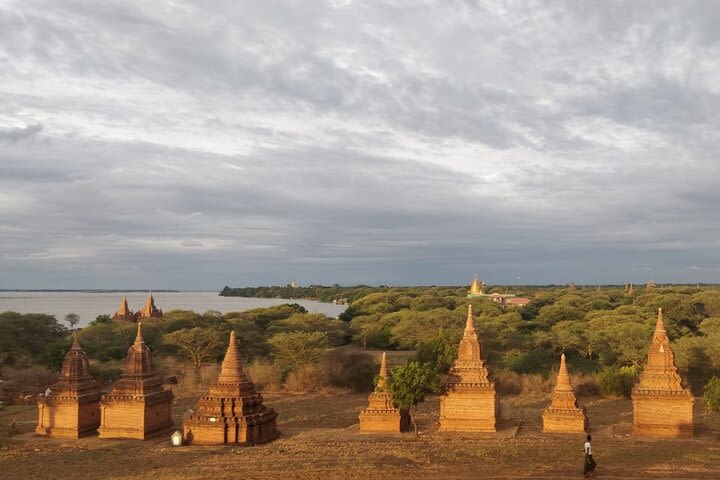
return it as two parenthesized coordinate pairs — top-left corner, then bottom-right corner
(388, 362), (440, 437)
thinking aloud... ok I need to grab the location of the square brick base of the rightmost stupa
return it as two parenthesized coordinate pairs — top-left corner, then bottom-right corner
(633, 393), (694, 438)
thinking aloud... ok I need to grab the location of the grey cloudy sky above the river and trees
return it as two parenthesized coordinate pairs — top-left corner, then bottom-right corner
(0, 0), (720, 290)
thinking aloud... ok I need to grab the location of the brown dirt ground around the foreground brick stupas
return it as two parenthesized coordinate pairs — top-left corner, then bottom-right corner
(0, 392), (720, 480)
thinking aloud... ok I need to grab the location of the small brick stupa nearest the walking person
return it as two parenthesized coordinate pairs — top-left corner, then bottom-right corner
(543, 353), (587, 433)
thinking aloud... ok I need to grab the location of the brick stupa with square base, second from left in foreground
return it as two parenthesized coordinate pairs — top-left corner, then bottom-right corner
(98, 323), (173, 440)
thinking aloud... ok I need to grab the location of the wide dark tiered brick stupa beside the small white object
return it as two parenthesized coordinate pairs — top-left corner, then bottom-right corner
(183, 332), (278, 445)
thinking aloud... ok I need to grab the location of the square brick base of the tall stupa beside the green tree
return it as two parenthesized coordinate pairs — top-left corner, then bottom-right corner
(440, 388), (500, 432)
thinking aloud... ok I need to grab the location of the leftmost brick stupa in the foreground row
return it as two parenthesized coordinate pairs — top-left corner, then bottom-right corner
(35, 336), (100, 438)
